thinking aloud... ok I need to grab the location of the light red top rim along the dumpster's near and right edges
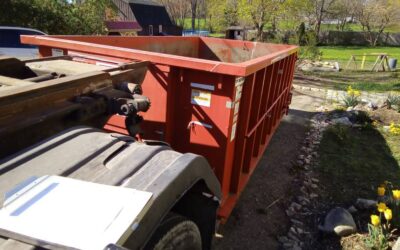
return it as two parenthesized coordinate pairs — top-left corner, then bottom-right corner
(21, 35), (299, 76)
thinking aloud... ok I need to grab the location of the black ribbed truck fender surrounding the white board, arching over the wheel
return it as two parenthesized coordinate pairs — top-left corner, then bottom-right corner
(0, 126), (221, 249)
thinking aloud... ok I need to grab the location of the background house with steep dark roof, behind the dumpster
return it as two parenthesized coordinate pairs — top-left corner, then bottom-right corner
(112, 0), (182, 36)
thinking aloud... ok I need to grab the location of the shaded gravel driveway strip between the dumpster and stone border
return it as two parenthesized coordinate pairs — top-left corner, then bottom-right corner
(214, 90), (324, 250)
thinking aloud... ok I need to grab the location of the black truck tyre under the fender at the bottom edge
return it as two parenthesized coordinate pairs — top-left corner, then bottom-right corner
(146, 213), (202, 250)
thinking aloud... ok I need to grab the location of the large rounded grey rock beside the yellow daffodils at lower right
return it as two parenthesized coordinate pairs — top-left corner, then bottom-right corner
(319, 207), (357, 237)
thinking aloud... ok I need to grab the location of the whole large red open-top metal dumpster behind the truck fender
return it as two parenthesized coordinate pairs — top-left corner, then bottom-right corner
(22, 36), (298, 221)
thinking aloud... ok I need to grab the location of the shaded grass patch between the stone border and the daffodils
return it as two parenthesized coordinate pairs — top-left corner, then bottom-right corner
(317, 117), (400, 205)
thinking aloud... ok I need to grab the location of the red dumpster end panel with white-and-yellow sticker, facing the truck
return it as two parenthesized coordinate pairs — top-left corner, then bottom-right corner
(168, 69), (235, 196)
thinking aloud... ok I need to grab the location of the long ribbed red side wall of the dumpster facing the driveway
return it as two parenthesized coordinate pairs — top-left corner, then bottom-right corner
(219, 54), (297, 220)
